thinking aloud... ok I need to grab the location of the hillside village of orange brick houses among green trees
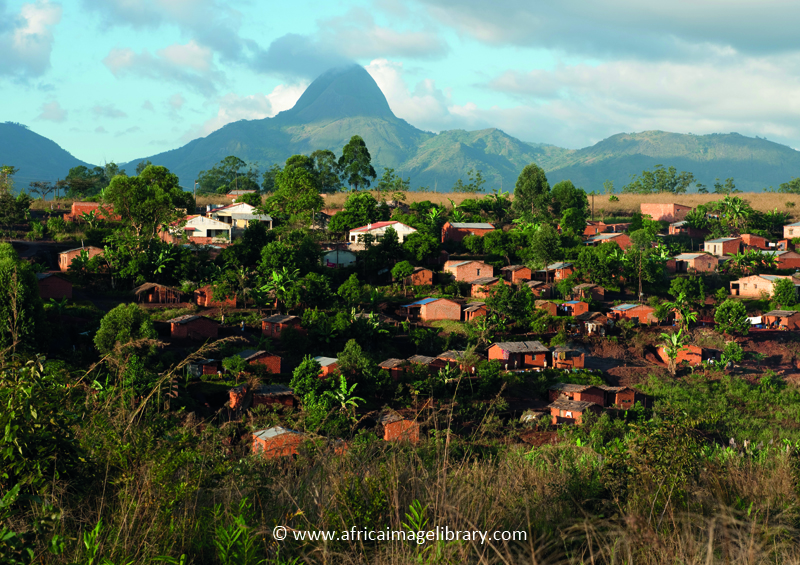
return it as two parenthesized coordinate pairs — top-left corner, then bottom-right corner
(6, 178), (800, 457)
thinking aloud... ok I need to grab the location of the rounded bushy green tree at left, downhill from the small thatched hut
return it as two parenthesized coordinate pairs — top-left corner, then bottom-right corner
(94, 304), (158, 358)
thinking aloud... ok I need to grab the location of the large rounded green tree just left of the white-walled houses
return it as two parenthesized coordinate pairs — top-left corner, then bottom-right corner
(105, 165), (191, 239)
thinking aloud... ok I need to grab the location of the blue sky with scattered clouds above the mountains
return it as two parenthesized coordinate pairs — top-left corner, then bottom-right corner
(0, 0), (800, 163)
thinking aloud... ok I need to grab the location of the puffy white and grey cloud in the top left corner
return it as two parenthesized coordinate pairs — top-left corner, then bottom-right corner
(0, 0), (62, 76)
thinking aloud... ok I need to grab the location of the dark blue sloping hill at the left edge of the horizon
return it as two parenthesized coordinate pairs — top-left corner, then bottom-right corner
(0, 122), (91, 189)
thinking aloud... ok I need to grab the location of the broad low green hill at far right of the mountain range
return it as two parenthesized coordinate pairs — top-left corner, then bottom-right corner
(539, 131), (800, 192)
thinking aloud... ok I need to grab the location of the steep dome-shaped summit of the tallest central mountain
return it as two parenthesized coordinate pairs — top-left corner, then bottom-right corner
(282, 65), (396, 123)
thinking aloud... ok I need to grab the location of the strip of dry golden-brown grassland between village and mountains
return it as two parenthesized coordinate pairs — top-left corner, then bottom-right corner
(31, 191), (800, 219)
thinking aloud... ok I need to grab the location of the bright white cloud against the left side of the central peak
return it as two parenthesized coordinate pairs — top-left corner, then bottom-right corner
(181, 83), (308, 143)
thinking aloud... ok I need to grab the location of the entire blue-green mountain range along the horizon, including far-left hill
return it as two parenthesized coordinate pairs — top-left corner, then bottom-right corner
(0, 65), (800, 192)
